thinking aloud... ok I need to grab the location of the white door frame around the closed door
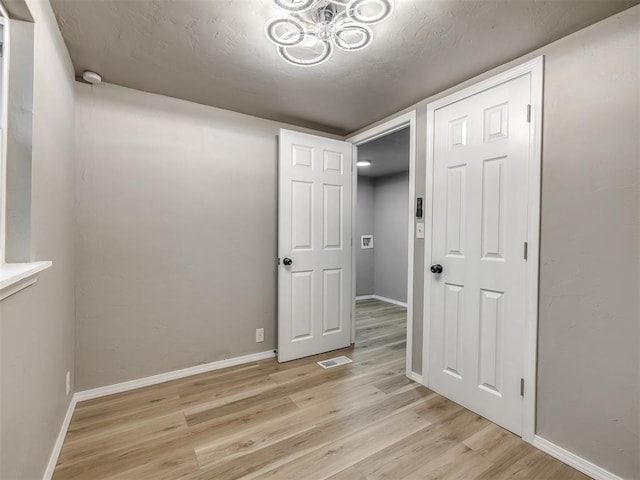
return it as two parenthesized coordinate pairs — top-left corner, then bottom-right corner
(422, 56), (544, 443)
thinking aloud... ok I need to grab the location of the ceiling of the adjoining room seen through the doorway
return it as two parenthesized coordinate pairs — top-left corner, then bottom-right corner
(358, 127), (410, 177)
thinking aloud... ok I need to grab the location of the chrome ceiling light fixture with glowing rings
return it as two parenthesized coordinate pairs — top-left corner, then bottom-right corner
(265, 0), (393, 67)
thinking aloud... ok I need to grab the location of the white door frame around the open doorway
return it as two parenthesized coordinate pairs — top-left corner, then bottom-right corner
(345, 110), (421, 382)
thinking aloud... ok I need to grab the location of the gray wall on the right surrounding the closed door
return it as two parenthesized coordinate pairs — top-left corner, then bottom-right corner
(354, 6), (640, 479)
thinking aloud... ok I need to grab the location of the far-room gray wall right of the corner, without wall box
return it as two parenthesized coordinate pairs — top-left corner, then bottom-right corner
(373, 172), (409, 302)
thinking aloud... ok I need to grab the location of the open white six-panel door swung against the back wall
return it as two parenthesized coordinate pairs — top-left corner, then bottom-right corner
(278, 130), (353, 362)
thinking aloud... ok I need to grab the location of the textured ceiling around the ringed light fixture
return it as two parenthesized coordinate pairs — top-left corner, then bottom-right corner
(51, 0), (640, 134)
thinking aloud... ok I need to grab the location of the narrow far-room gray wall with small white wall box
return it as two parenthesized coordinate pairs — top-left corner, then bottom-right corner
(353, 176), (375, 295)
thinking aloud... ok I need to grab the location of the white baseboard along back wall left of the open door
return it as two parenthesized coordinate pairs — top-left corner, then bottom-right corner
(74, 350), (275, 402)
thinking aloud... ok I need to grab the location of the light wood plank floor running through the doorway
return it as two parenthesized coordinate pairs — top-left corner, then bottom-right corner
(54, 300), (587, 480)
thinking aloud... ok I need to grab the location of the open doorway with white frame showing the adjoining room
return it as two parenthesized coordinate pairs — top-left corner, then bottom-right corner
(347, 112), (419, 381)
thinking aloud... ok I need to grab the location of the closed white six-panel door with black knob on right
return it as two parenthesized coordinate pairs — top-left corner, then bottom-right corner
(427, 75), (531, 434)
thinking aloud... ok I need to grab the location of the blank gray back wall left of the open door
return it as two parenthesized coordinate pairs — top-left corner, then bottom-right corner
(76, 83), (340, 389)
